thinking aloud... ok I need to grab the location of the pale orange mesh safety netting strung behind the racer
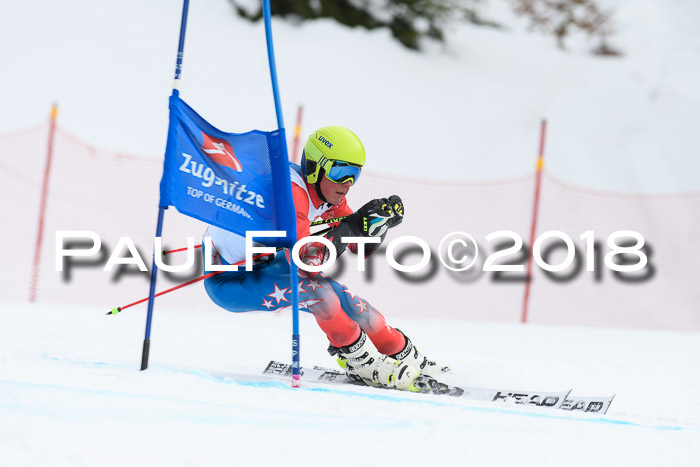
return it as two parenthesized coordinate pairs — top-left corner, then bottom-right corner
(0, 123), (700, 330)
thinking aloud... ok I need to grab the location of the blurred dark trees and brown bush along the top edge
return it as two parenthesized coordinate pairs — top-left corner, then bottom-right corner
(234, 0), (617, 55)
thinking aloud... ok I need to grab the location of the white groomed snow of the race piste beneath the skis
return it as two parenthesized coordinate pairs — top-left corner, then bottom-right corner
(0, 302), (700, 467)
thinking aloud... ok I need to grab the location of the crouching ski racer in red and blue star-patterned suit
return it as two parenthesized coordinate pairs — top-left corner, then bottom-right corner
(204, 126), (447, 391)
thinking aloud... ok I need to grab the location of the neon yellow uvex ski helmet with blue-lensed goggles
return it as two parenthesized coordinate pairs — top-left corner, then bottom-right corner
(301, 126), (365, 188)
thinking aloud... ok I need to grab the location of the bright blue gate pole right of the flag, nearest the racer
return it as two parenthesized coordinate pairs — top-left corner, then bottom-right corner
(263, 0), (301, 387)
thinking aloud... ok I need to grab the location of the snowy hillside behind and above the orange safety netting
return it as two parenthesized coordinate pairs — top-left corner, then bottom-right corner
(0, 0), (700, 192)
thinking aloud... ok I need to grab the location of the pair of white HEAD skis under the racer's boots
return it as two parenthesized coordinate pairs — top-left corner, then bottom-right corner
(263, 360), (615, 414)
